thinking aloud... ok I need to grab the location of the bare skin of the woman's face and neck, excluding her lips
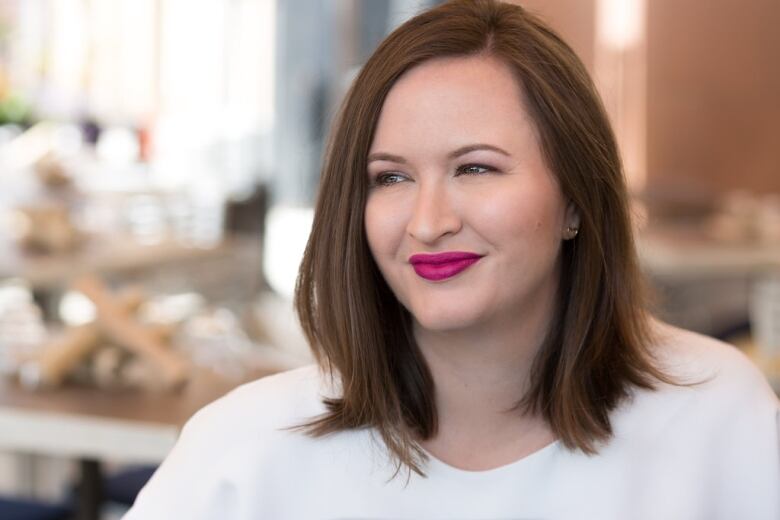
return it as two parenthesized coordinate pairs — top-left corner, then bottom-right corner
(365, 55), (578, 470)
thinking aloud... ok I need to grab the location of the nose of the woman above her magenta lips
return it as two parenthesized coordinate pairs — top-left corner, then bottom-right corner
(406, 179), (462, 243)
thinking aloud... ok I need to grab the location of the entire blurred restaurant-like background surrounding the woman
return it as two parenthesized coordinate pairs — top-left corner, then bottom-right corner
(0, 0), (780, 519)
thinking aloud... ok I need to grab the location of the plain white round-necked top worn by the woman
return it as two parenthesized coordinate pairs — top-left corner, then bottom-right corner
(125, 326), (780, 520)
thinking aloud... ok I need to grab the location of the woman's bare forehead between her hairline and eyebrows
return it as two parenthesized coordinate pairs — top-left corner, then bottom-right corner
(372, 55), (535, 149)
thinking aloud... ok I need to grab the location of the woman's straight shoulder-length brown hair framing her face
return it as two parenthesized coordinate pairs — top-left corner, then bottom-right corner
(295, 0), (668, 474)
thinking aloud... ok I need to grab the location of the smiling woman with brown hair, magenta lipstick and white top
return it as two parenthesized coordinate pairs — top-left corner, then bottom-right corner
(126, 0), (780, 520)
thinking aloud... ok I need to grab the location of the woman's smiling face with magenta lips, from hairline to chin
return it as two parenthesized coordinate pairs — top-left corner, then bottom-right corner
(365, 56), (577, 331)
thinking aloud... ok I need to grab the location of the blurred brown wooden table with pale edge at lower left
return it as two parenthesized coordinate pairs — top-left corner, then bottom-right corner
(0, 369), (274, 520)
